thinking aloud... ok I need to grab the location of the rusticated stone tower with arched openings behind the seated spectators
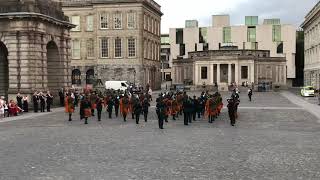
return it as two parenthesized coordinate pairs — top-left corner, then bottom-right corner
(0, 0), (74, 100)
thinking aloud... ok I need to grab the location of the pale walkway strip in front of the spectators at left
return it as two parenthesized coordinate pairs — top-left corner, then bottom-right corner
(0, 107), (64, 123)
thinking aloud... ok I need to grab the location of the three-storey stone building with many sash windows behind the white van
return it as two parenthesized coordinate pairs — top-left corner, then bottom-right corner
(62, 0), (162, 89)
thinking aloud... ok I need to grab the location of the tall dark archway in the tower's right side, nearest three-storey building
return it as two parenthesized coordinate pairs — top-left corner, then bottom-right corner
(47, 41), (64, 91)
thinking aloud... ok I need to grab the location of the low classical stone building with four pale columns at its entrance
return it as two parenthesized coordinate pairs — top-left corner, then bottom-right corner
(172, 47), (286, 90)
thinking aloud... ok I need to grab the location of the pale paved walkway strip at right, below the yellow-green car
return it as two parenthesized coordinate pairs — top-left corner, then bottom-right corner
(281, 91), (320, 123)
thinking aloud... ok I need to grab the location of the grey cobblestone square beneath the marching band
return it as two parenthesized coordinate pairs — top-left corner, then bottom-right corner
(0, 93), (320, 180)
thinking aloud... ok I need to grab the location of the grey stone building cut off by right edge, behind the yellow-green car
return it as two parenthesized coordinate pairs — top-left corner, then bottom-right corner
(301, 2), (320, 89)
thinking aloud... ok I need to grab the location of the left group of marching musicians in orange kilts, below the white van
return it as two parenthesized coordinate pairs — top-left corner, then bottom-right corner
(65, 91), (151, 124)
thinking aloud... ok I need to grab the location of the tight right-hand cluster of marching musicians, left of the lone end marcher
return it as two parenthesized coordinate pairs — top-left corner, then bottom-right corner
(156, 92), (223, 129)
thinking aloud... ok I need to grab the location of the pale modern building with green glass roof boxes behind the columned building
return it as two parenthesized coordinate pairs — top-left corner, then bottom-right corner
(169, 15), (296, 86)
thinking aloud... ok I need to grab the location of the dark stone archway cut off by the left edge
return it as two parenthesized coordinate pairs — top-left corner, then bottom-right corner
(0, 41), (9, 99)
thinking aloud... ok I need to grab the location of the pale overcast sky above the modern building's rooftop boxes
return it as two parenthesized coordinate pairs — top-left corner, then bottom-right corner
(155, 0), (318, 33)
